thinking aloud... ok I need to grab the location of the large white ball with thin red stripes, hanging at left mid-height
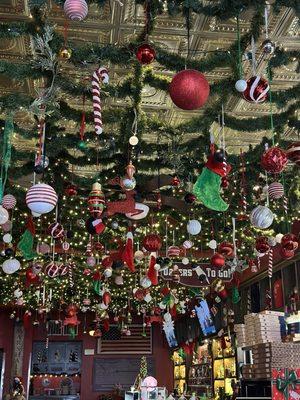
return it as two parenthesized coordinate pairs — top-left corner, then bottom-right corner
(26, 183), (58, 214)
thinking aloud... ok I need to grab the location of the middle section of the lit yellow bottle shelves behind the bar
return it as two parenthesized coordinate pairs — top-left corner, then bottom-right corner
(188, 340), (212, 397)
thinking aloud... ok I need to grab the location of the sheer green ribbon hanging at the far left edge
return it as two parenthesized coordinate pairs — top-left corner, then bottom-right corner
(0, 115), (14, 202)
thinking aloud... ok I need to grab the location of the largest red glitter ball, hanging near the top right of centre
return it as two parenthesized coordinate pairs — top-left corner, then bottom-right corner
(169, 69), (209, 110)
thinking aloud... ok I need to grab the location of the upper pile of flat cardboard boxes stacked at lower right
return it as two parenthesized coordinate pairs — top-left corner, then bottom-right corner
(245, 311), (285, 346)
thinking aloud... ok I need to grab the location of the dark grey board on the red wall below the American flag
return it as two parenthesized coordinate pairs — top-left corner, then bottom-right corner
(93, 357), (155, 392)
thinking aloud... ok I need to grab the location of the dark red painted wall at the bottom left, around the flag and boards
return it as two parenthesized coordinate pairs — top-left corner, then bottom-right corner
(0, 311), (173, 400)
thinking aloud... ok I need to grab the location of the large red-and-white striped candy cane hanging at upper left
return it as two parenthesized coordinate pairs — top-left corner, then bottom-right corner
(92, 67), (109, 135)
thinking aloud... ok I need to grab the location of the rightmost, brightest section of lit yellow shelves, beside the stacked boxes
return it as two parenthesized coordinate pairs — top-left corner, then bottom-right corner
(212, 336), (236, 400)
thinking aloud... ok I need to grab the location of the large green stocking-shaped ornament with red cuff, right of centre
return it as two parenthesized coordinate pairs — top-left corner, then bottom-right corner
(193, 154), (231, 212)
